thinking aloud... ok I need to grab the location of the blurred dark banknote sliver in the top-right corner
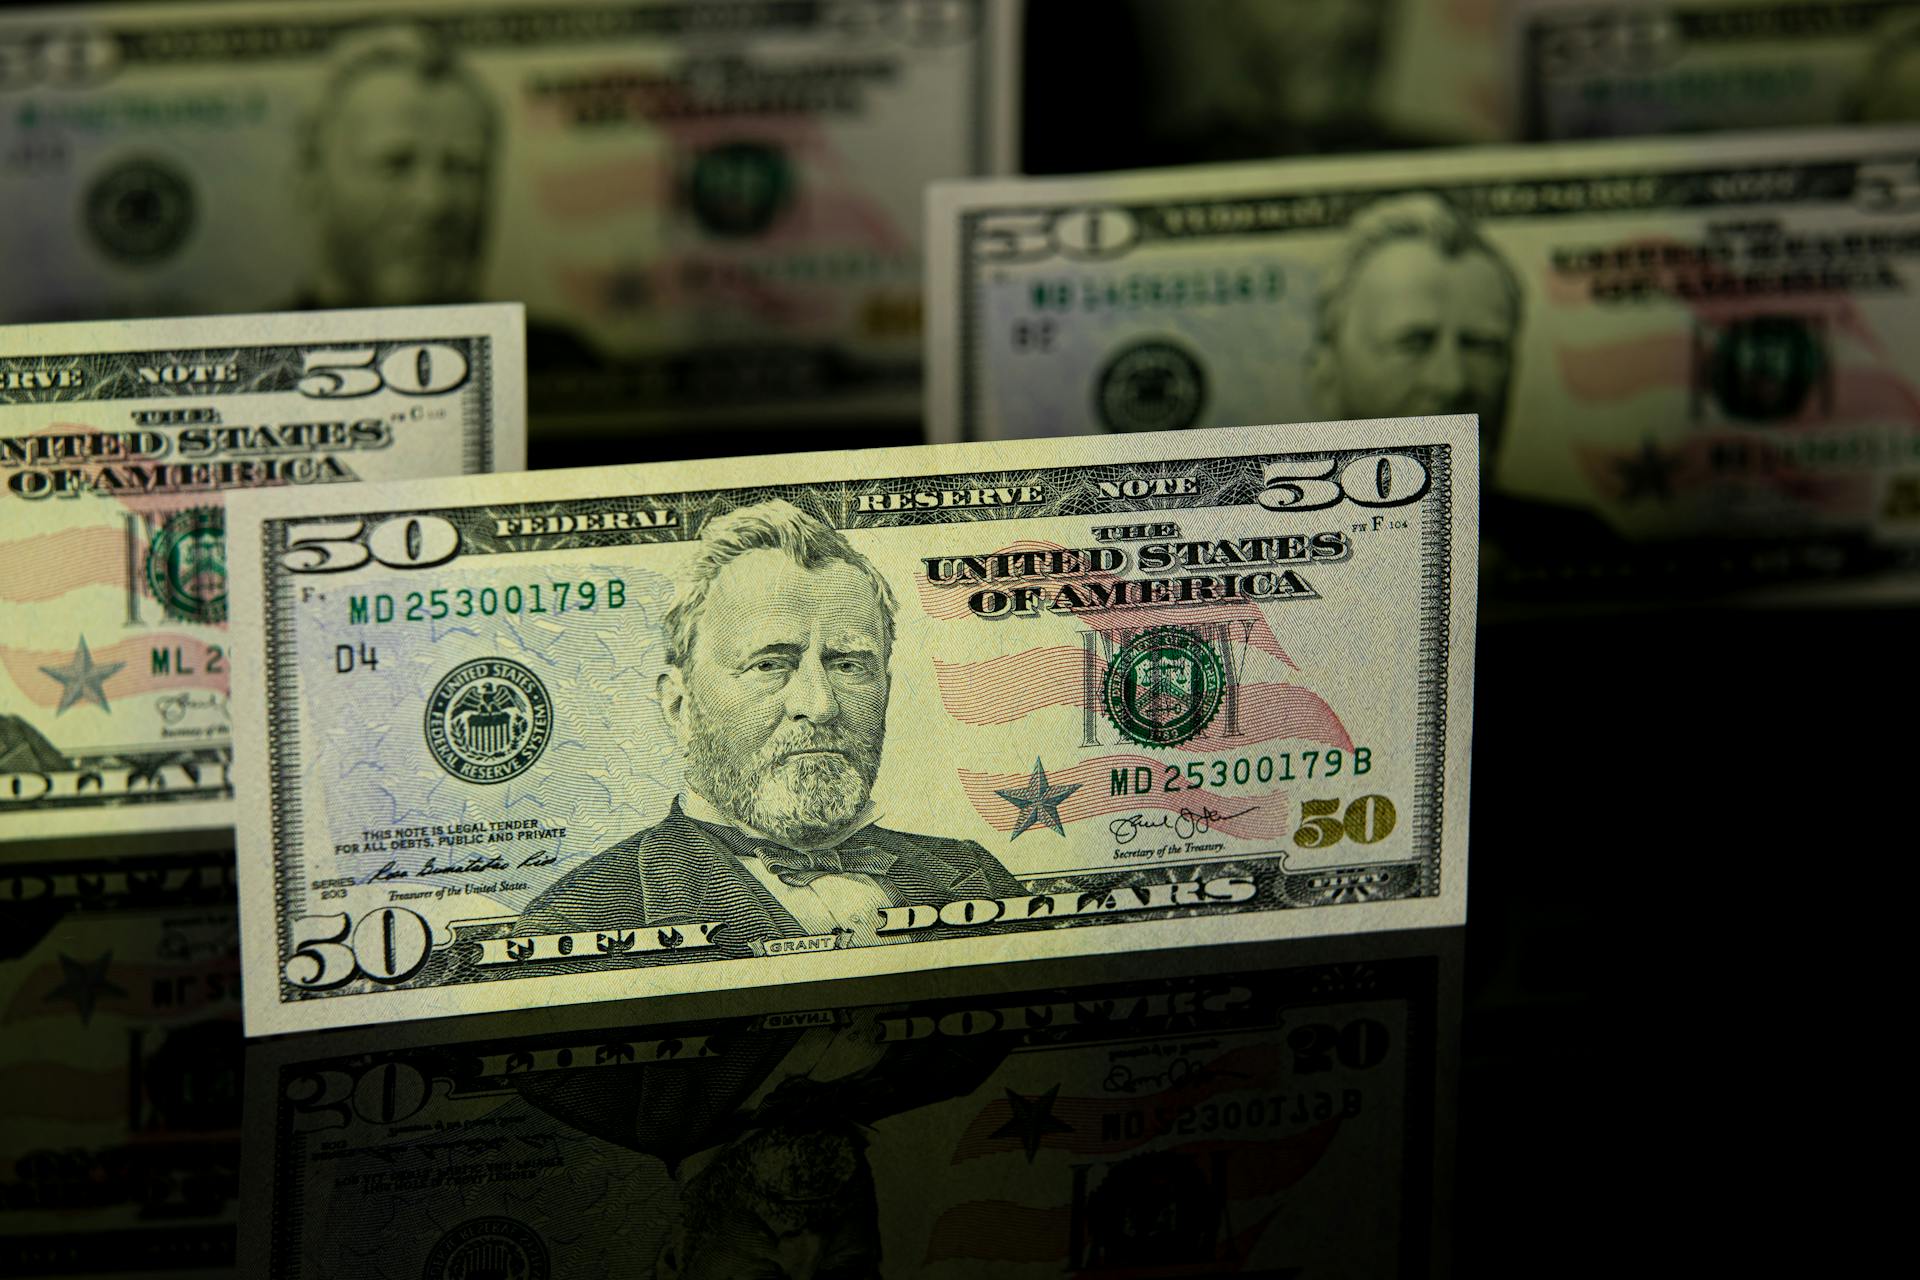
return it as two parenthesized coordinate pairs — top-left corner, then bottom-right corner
(1507, 0), (1920, 140)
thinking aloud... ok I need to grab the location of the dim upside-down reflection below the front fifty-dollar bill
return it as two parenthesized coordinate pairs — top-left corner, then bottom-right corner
(242, 933), (1455, 1280)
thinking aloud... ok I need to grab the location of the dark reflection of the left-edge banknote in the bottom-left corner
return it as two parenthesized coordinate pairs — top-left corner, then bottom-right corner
(0, 850), (240, 1280)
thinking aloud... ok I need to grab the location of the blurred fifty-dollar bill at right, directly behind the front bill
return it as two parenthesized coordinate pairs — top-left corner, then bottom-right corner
(927, 129), (1920, 597)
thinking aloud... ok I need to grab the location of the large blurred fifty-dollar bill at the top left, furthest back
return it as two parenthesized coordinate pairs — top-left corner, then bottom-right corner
(0, 0), (1010, 428)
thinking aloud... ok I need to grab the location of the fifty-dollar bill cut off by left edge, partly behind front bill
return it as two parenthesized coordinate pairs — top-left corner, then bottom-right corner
(0, 307), (526, 852)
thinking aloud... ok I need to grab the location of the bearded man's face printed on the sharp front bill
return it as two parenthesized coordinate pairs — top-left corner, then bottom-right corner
(680, 549), (887, 846)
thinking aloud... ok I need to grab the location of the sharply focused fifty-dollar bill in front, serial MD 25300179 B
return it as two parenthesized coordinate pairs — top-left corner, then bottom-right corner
(234, 418), (1478, 1034)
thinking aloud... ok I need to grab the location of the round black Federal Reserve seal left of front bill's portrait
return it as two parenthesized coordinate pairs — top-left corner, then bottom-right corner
(426, 658), (553, 787)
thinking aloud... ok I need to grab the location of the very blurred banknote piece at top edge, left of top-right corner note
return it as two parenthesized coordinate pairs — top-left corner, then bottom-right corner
(1131, 0), (1505, 161)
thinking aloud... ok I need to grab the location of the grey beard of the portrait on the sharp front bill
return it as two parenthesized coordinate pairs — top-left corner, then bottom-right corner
(687, 700), (883, 848)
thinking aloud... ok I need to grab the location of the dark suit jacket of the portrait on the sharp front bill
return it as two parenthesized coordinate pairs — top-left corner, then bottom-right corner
(515, 800), (1025, 971)
